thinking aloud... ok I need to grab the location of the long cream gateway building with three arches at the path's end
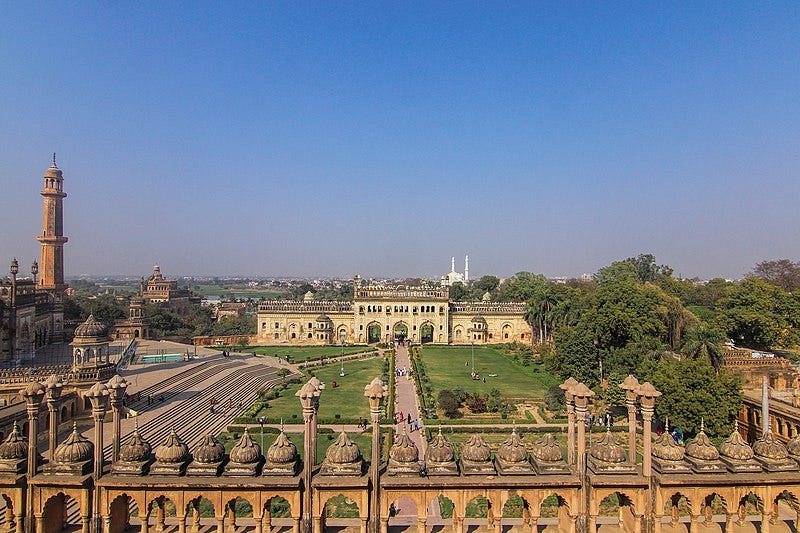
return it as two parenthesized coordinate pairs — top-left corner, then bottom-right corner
(257, 276), (531, 345)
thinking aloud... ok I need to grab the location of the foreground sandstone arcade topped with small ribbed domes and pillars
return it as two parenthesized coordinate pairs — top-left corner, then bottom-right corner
(0, 376), (800, 533)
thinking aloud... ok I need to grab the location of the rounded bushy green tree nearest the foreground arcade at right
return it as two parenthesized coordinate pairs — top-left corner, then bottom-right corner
(638, 359), (742, 437)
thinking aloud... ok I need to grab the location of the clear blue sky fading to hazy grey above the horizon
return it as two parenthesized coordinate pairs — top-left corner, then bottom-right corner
(0, 1), (800, 277)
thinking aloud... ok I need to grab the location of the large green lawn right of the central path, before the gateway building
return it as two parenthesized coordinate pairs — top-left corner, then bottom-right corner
(420, 346), (559, 398)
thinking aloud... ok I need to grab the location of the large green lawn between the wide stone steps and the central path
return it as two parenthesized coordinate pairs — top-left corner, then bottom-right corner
(256, 357), (388, 424)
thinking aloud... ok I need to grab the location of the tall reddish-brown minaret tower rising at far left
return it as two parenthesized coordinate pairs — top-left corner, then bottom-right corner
(36, 154), (67, 293)
